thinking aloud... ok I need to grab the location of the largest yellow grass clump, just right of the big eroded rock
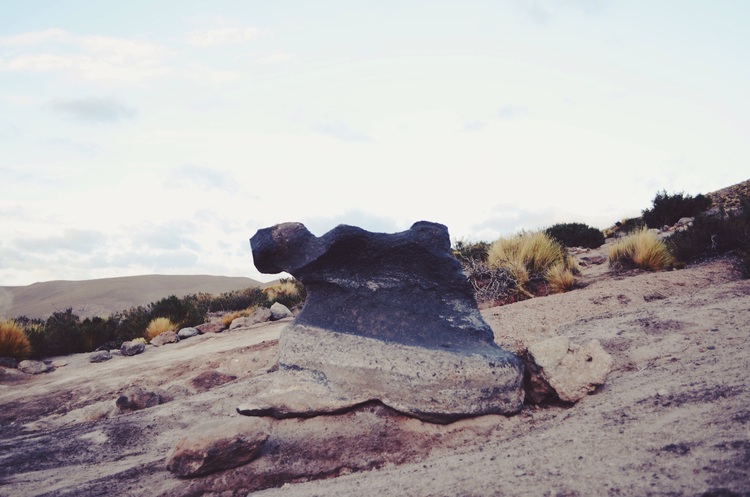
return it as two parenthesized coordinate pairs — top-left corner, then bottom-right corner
(487, 231), (580, 297)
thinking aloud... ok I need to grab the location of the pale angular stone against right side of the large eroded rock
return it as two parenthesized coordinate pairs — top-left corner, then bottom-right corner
(526, 337), (613, 404)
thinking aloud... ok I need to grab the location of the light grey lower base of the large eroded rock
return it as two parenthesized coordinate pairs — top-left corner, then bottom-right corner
(237, 324), (524, 423)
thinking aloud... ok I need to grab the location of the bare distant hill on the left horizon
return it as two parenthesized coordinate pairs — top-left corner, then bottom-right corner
(0, 275), (266, 318)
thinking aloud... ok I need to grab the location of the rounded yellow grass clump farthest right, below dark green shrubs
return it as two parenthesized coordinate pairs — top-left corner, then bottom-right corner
(607, 228), (674, 271)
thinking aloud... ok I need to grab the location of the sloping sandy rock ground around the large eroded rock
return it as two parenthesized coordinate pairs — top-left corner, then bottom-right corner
(0, 254), (750, 497)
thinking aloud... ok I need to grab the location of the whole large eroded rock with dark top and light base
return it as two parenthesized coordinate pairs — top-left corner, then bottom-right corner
(238, 221), (524, 422)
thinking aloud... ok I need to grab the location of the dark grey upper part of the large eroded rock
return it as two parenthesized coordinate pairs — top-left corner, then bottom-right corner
(250, 221), (497, 351)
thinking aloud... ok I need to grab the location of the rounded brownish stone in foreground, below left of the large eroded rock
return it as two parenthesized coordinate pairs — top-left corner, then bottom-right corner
(166, 417), (271, 477)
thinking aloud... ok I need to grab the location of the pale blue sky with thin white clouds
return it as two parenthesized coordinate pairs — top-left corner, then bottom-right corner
(0, 0), (750, 286)
